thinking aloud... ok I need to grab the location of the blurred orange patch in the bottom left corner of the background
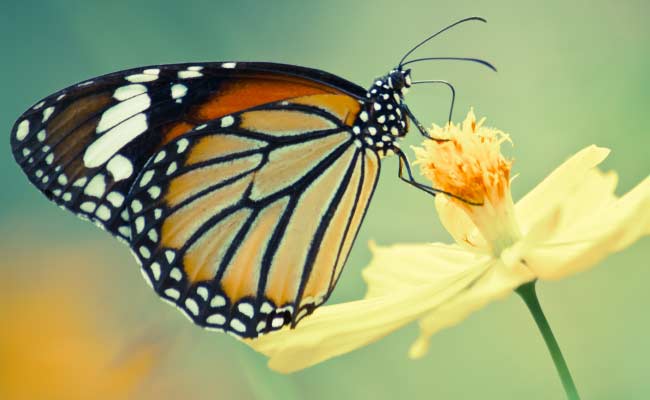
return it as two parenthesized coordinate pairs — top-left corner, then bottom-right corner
(0, 244), (162, 400)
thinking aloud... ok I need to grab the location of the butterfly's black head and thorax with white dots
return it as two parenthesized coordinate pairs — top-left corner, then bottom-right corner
(353, 70), (411, 155)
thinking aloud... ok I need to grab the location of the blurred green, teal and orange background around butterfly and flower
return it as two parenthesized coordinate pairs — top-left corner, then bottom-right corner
(0, 0), (650, 400)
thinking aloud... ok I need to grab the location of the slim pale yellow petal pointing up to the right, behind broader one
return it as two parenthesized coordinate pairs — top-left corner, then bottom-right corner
(515, 145), (609, 234)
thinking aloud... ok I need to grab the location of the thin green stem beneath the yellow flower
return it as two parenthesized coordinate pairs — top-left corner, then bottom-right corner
(516, 281), (580, 400)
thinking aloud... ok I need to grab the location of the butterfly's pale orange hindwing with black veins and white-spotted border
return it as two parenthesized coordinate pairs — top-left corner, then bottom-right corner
(128, 94), (379, 337)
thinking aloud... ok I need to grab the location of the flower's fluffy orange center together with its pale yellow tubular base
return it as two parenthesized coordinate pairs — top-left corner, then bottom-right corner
(415, 110), (521, 256)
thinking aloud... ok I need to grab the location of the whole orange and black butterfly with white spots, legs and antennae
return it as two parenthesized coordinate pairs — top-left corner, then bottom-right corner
(11, 17), (494, 338)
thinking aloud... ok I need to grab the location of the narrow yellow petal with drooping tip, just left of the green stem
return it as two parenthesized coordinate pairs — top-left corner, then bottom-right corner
(409, 256), (535, 358)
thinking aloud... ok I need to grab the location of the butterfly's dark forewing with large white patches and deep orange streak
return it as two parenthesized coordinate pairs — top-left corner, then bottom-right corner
(11, 63), (360, 240)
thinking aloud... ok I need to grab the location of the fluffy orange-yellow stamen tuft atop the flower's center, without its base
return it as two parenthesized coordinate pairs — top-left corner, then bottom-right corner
(414, 110), (512, 207)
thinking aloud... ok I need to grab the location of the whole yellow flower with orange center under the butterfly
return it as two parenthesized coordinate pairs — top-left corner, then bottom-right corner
(248, 111), (650, 372)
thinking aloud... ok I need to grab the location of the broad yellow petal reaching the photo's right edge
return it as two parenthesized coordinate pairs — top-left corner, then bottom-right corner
(525, 171), (650, 279)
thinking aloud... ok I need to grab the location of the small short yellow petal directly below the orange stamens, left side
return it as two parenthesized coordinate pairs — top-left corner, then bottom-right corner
(435, 195), (489, 251)
